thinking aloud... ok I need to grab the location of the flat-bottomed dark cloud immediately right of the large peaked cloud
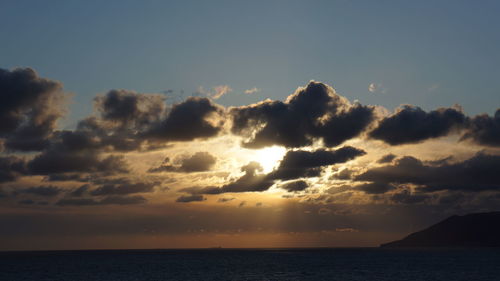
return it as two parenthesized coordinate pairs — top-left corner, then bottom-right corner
(369, 105), (467, 145)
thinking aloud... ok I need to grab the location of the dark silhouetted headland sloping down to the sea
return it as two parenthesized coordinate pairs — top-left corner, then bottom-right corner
(380, 212), (500, 248)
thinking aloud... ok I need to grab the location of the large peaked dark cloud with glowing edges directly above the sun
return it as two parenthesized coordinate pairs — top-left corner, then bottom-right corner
(230, 81), (374, 148)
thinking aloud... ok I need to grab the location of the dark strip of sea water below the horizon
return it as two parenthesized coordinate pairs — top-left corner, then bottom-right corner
(0, 248), (500, 281)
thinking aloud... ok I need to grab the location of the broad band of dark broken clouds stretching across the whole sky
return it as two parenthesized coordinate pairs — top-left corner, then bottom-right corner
(0, 68), (500, 213)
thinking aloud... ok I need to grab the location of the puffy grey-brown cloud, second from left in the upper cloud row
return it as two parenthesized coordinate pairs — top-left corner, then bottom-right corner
(50, 90), (166, 151)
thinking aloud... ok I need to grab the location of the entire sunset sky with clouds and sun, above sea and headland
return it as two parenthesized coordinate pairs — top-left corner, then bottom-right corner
(0, 0), (500, 250)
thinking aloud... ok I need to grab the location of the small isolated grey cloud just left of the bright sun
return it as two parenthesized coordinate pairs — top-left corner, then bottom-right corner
(149, 152), (217, 173)
